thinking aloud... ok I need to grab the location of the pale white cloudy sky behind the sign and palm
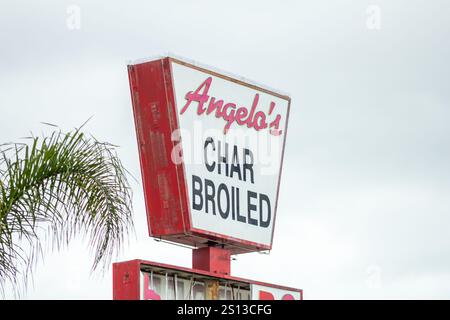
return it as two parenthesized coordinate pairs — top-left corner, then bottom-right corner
(0, 0), (450, 299)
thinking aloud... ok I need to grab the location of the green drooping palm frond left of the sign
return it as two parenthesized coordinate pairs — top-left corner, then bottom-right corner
(0, 129), (133, 289)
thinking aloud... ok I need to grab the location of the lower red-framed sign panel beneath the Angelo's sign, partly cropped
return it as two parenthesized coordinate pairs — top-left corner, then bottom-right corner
(113, 260), (302, 300)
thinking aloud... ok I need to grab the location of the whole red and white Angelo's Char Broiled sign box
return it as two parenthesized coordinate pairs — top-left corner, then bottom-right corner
(128, 57), (290, 254)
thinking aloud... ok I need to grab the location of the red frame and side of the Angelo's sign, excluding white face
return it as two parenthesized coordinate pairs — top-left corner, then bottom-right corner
(128, 57), (290, 254)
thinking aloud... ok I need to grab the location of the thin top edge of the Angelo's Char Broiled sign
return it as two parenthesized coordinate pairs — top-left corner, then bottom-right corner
(127, 53), (291, 100)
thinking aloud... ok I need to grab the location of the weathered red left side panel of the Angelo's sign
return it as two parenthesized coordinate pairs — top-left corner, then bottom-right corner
(128, 59), (190, 237)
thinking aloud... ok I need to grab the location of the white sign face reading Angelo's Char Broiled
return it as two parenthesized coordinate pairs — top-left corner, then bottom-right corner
(172, 61), (289, 246)
